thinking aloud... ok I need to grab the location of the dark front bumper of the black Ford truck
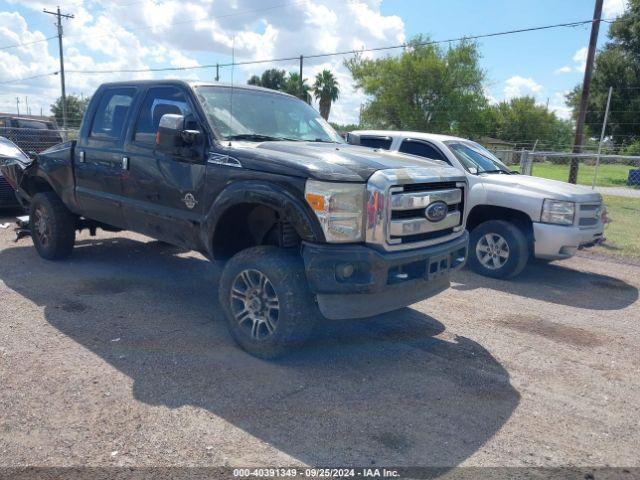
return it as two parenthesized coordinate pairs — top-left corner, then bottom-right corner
(302, 231), (469, 319)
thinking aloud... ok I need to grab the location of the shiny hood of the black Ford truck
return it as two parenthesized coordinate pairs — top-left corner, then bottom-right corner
(228, 141), (460, 182)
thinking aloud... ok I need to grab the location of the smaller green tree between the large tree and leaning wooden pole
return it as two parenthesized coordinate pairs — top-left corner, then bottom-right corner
(490, 96), (573, 150)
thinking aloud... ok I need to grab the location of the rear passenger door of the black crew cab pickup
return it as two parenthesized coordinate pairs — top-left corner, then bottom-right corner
(74, 87), (136, 228)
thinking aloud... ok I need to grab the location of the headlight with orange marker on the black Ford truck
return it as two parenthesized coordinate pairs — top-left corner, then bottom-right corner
(304, 180), (365, 243)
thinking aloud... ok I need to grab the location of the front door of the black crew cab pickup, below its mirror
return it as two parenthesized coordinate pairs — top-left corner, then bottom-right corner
(122, 85), (206, 248)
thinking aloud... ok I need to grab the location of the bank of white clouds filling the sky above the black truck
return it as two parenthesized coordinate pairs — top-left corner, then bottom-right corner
(0, 0), (405, 123)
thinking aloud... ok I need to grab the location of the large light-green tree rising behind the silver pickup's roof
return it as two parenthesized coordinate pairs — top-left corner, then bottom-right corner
(345, 36), (491, 137)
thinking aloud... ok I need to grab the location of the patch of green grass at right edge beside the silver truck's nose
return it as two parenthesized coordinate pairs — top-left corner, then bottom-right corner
(593, 195), (640, 259)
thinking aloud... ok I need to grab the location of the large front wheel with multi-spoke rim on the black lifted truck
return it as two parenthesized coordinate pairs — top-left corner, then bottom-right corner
(219, 246), (320, 358)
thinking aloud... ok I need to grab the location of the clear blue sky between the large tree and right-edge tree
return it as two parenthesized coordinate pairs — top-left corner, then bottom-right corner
(382, 0), (620, 116)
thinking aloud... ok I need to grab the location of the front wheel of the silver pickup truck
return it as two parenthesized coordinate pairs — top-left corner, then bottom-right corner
(469, 220), (529, 278)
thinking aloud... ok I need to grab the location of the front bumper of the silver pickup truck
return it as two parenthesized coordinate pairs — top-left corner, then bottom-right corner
(533, 222), (604, 260)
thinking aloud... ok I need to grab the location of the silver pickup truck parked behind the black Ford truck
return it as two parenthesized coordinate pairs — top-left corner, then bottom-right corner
(348, 130), (606, 278)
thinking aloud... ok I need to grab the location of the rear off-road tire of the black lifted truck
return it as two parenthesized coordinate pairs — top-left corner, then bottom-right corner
(29, 192), (77, 260)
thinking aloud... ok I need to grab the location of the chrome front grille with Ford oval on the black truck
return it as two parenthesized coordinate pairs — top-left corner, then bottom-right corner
(366, 167), (467, 250)
